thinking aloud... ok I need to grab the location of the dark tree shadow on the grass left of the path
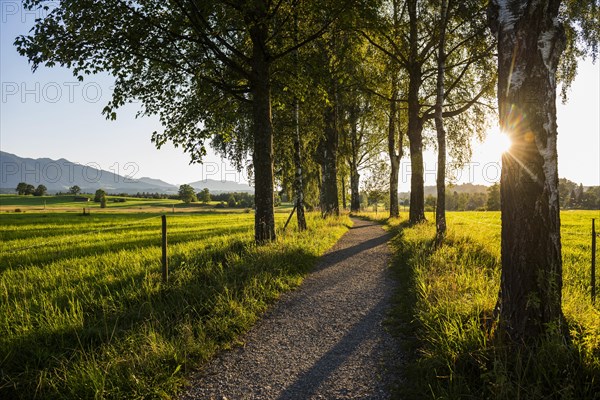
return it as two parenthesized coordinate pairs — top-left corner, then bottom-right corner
(0, 240), (318, 399)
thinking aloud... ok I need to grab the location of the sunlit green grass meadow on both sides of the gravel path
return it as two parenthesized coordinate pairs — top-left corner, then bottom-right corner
(0, 202), (600, 400)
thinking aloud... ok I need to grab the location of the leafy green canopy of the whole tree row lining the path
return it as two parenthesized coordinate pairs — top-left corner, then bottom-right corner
(15, 0), (600, 250)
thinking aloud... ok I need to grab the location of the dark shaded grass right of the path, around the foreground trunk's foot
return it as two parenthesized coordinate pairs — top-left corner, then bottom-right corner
(389, 224), (600, 399)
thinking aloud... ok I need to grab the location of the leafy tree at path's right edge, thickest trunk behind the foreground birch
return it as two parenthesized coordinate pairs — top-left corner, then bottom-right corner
(362, 0), (493, 223)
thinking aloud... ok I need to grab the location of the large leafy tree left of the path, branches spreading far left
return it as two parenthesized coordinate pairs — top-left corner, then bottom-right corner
(16, 0), (368, 242)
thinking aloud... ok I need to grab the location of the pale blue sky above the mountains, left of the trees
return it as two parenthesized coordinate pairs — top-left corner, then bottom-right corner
(0, 0), (246, 184)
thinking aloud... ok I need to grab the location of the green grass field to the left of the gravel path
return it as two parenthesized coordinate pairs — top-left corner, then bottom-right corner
(0, 213), (349, 399)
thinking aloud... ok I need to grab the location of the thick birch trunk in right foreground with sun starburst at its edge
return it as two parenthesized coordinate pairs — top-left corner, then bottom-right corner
(488, 0), (565, 342)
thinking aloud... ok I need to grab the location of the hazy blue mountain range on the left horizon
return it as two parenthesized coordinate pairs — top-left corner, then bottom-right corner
(0, 151), (254, 194)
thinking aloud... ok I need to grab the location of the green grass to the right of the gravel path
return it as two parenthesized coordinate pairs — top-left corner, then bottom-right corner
(376, 211), (600, 400)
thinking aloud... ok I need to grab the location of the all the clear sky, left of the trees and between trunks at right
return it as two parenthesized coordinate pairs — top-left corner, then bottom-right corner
(0, 0), (600, 191)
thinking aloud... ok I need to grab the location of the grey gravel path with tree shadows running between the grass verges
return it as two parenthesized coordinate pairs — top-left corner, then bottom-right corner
(183, 219), (401, 400)
